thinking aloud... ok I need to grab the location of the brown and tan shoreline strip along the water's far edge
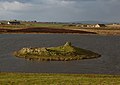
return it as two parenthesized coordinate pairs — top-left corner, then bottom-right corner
(0, 27), (120, 36)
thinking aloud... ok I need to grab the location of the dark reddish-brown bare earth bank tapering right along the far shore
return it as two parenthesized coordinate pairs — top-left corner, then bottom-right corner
(0, 27), (96, 34)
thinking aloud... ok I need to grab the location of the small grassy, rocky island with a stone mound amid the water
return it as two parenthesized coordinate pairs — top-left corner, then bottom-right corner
(14, 42), (101, 61)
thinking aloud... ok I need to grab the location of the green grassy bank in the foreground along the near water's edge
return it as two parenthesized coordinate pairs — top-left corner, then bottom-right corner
(0, 73), (120, 85)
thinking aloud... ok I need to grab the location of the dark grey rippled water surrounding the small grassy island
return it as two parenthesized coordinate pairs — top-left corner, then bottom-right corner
(0, 34), (120, 74)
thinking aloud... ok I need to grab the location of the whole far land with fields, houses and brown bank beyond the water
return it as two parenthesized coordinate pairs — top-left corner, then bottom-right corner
(0, 21), (120, 35)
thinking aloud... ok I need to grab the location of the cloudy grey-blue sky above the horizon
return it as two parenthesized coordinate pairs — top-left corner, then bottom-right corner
(0, 0), (120, 22)
